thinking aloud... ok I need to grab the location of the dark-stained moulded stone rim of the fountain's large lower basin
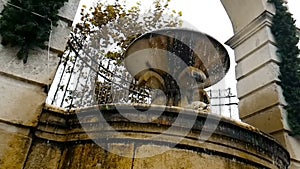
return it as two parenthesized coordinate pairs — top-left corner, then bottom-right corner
(35, 105), (288, 168)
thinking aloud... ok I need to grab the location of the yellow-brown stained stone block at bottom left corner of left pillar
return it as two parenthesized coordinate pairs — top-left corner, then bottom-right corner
(0, 123), (31, 169)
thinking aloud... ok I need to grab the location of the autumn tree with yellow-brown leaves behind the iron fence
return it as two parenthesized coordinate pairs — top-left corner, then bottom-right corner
(69, 0), (182, 107)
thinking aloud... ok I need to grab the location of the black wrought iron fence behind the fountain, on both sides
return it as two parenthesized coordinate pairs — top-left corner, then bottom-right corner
(46, 35), (238, 118)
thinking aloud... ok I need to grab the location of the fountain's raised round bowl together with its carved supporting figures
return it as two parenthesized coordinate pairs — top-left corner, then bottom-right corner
(124, 28), (230, 107)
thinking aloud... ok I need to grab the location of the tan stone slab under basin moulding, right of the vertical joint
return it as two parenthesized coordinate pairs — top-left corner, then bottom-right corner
(133, 145), (256, 169)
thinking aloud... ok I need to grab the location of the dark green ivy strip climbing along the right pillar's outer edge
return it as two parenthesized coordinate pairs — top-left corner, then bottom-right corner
(269, 0), (300, 136)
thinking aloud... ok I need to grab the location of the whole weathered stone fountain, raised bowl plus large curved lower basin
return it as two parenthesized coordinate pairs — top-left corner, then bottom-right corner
(25, 29), (290, 169)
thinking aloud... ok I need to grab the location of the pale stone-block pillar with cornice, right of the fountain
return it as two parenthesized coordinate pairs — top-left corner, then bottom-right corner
(222, 0), (300, 169)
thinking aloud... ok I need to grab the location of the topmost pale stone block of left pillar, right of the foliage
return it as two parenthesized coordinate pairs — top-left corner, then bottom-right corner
(58, 0), (80, 22)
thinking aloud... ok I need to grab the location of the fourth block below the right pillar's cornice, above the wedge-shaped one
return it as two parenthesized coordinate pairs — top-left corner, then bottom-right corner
(239, 83), (285, 119)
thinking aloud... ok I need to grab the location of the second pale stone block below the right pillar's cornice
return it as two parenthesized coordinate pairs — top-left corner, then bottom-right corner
(235, 43), (280, 79)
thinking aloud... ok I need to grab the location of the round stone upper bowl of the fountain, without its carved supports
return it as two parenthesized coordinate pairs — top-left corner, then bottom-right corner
(124, 28), (230, 88)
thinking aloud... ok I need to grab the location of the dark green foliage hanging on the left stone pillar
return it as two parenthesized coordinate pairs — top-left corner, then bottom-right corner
(0, 0), (67, 63)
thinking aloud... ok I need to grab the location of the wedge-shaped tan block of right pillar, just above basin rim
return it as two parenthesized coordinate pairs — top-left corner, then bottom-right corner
(242, 106), (284, 133)
